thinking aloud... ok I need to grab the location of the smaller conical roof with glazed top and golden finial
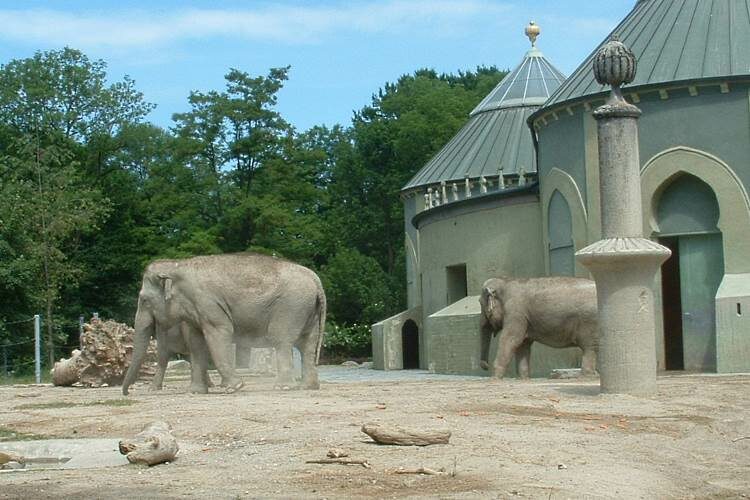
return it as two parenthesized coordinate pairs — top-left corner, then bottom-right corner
(403, 23), (565, 190)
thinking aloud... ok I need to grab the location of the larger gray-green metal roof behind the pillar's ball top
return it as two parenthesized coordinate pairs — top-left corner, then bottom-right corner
(544, 0), (750, 109)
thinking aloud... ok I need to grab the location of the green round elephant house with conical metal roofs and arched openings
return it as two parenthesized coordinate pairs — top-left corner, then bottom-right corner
(373, 0), (750, 376)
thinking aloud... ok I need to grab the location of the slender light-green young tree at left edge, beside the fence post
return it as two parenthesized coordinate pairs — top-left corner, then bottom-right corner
(0, 139), (109, 364)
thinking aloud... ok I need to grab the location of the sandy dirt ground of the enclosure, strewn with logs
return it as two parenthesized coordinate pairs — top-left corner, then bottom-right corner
(0, 367), (750, 499)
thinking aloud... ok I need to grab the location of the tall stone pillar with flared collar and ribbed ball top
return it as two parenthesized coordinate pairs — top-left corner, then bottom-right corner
(576, 39), (670, 395)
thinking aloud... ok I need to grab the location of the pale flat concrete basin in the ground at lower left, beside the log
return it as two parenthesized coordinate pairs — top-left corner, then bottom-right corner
(0, 439), (130, 474)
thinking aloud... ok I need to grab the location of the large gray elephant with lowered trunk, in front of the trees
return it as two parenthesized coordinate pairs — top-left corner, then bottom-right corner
(122, 253), (326, 394)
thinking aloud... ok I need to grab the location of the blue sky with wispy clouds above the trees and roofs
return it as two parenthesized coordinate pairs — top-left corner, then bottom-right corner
(0, 0), (635, 130)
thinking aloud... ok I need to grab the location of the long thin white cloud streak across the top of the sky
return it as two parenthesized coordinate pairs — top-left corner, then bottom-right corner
(0, 0), (507, 48)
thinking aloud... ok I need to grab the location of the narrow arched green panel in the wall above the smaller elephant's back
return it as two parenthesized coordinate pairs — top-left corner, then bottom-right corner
(547, 190), (575, 276)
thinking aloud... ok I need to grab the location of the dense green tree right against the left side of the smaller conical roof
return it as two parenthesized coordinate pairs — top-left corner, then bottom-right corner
(329, 68), (505, 313)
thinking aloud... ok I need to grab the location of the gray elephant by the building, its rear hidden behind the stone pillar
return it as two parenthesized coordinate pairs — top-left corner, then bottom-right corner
(479, 277), (599, 378)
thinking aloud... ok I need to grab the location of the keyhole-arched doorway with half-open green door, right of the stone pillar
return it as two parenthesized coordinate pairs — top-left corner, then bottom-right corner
(655, 174), (724, 371)
